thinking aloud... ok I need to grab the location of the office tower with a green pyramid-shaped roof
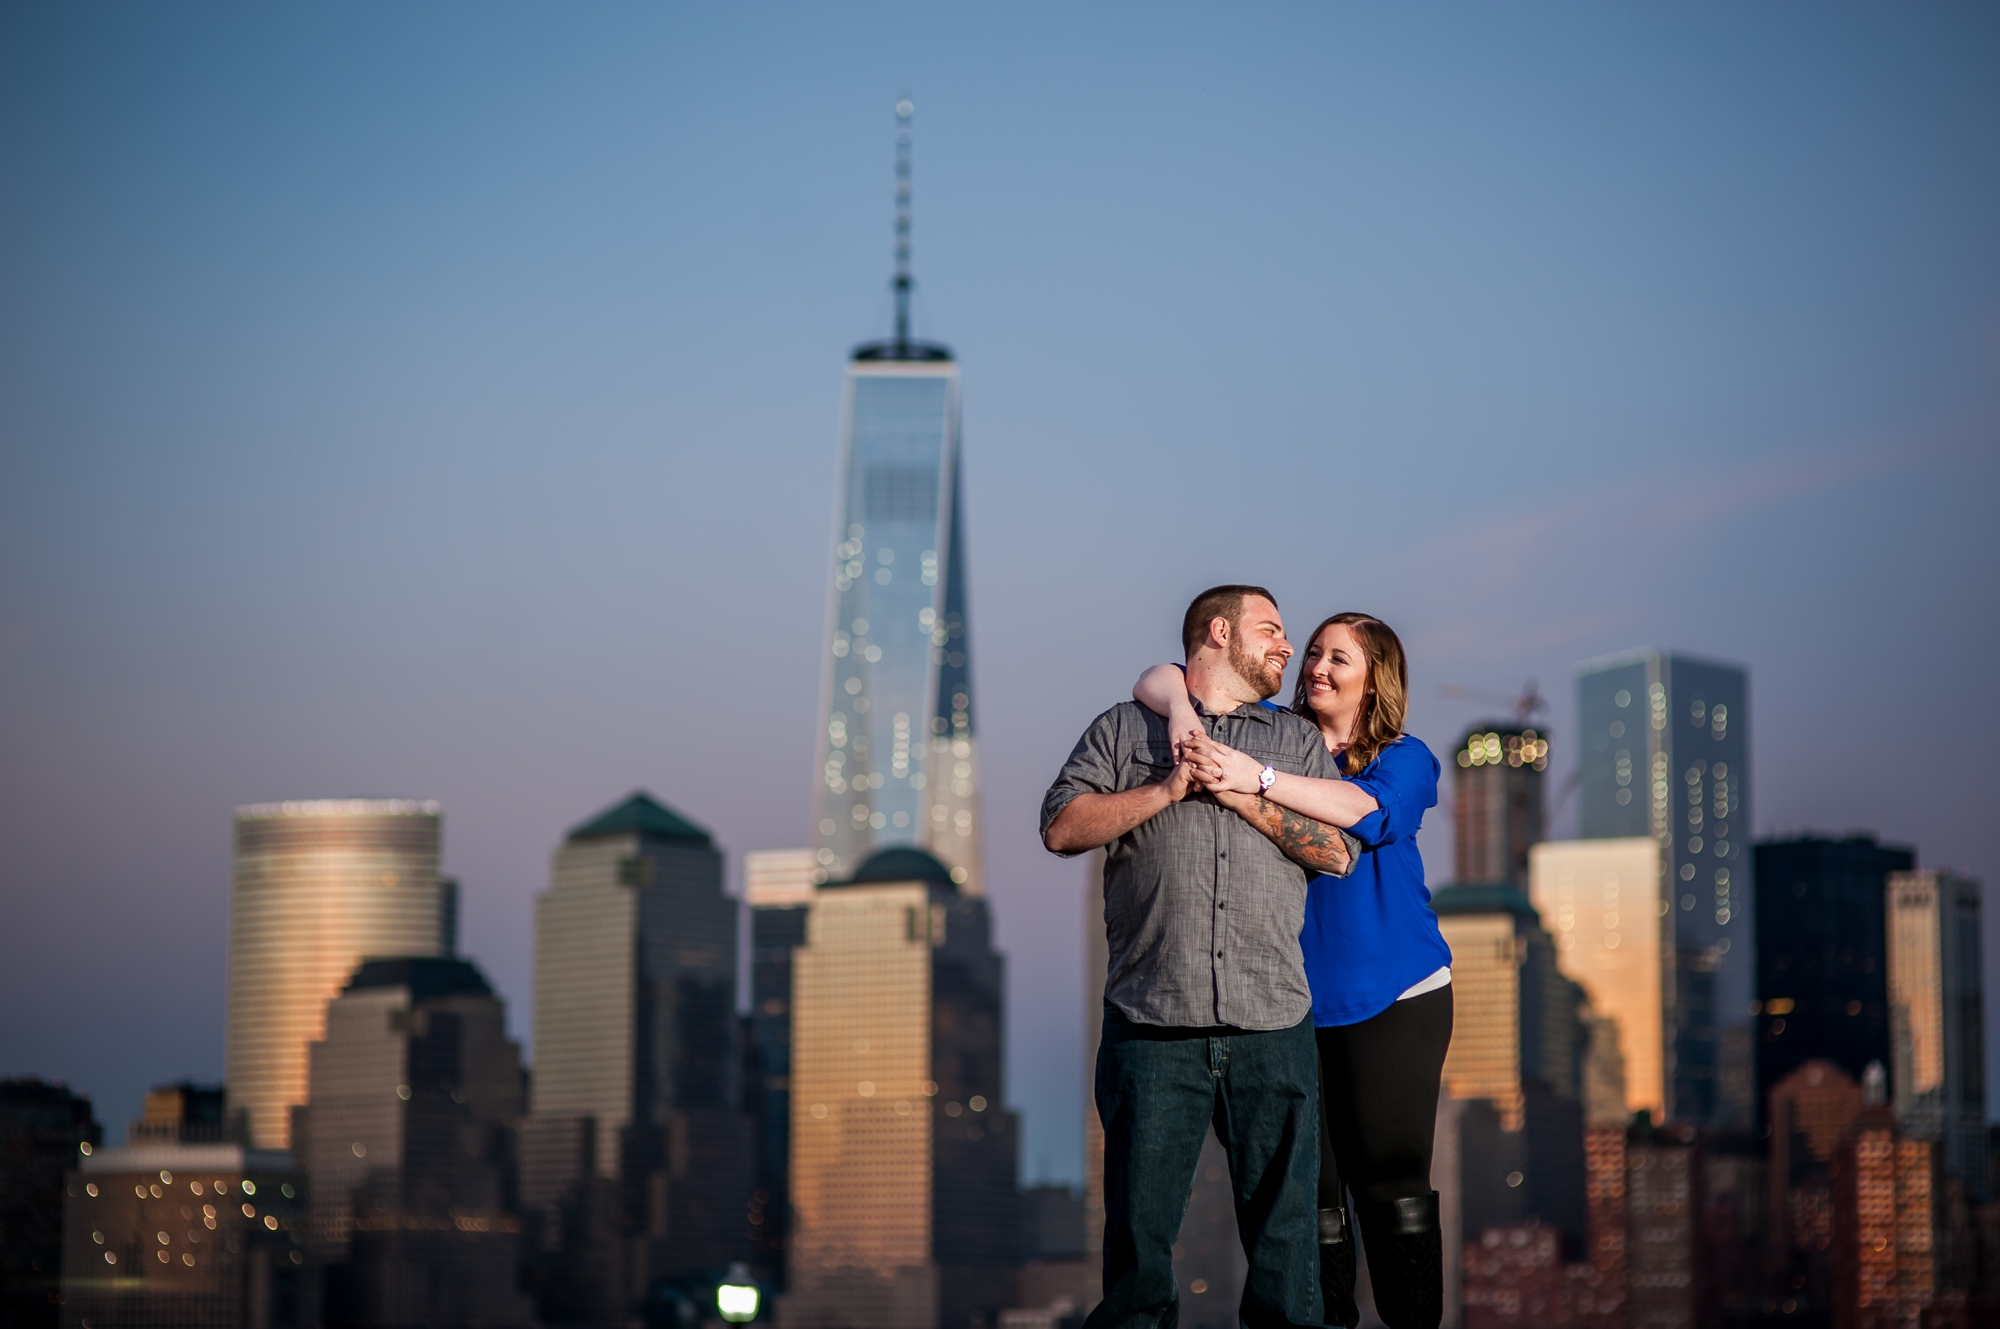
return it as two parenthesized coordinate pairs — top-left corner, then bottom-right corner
(520, 793), (756, 1323)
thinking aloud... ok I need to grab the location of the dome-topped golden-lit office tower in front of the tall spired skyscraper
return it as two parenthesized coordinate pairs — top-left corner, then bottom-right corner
(782, 849), (1020, 1329)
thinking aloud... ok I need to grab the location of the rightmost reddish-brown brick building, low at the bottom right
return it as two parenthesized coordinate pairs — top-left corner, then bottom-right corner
(1830, 1104), (1964, 1329)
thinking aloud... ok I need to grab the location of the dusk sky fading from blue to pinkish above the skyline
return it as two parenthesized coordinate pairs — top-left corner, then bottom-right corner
(0, 4), (2000, 1181)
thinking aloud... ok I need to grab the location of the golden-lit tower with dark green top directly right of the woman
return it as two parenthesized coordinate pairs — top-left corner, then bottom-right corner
(1432, 885), (1590, 1267)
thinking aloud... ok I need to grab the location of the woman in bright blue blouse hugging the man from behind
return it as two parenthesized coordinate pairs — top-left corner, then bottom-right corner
(1132, 614), (1452, 1329)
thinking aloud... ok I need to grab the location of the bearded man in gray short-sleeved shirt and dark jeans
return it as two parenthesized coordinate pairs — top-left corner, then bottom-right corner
(1042, 586), (1358, 1329)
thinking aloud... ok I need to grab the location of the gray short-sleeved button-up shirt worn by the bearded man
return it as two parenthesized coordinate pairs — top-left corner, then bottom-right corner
(1042, 701), (1360, 1029)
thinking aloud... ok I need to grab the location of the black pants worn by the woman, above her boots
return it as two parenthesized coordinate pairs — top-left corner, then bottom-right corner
(1314, 985), (1452, 1209)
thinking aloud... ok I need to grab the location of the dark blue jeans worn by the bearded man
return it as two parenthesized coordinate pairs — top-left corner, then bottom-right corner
(1084, 1005), (1322, 1329)
